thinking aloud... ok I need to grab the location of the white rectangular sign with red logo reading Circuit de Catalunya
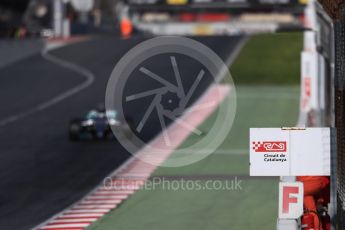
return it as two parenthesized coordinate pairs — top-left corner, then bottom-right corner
(249, 128), (334, 176)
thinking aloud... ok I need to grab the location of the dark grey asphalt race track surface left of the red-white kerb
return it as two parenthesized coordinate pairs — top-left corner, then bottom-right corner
(0, 36), (242, 230)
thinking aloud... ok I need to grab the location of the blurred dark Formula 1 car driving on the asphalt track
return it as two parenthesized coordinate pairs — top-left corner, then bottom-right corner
(69, 109), (131, 141)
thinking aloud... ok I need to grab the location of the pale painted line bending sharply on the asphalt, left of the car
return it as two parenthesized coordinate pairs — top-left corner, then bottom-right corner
(0, 42), (95, 127)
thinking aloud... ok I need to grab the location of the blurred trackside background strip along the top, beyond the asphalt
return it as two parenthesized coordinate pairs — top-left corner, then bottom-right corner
(0, 0), (305, 38)
